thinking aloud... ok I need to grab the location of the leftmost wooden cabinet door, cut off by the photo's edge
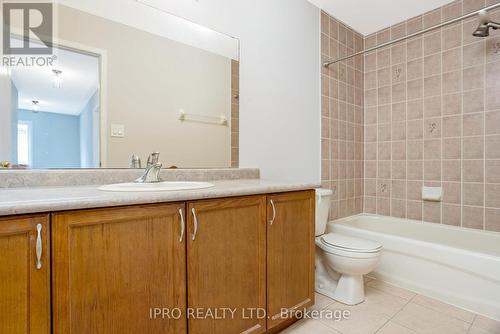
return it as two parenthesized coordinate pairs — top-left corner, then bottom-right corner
(0, 215), (50, 334)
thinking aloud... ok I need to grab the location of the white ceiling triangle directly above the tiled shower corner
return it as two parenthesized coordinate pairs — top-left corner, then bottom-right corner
(309, 0), (453, 36)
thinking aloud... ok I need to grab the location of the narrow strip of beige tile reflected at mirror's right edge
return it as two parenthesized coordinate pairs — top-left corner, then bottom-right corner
(231, 60), (240, 168)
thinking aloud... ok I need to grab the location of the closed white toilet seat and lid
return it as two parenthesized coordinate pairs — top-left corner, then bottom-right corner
(320, 233), (382, 254)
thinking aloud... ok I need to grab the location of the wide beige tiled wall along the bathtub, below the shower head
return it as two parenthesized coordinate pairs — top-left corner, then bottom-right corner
(362, 0), (500, 231)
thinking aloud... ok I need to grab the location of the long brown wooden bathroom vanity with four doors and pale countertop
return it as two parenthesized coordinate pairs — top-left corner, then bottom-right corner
(0, 175), (315, 334)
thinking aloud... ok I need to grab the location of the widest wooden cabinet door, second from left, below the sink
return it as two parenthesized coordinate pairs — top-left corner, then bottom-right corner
(52, 203), (186, 334)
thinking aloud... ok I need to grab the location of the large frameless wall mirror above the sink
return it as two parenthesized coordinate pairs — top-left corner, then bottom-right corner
(0, 0), (239, 169)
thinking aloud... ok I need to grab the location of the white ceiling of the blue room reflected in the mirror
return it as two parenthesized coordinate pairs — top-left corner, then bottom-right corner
(12, 44), (99, 115)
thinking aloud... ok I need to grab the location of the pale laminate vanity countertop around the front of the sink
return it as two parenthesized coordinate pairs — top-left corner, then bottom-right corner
(0, 179), (320, 216)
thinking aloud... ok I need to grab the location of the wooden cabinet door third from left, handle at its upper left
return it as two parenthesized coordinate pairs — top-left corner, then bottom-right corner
(187, 196), (266, 334)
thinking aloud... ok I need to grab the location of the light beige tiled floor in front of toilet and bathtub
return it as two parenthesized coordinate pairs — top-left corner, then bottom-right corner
(281, 279), (500, 334)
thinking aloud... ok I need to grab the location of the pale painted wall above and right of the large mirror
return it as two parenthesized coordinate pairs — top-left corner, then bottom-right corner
(54, 0), (321, 182)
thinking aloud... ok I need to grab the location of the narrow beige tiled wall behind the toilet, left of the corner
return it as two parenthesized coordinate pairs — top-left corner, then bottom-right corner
(321, 12), (364, 219)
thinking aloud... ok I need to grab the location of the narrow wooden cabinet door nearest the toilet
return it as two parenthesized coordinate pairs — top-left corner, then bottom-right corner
(267, 191), (315, 328)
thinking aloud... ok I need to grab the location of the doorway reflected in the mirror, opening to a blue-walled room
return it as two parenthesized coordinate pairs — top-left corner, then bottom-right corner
(10, 47), (100, 169)
